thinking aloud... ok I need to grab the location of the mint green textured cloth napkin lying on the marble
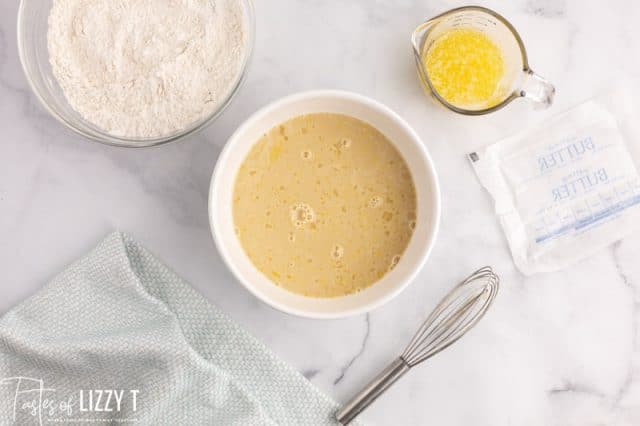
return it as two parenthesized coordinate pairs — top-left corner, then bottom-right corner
(0, 233), (348, 425)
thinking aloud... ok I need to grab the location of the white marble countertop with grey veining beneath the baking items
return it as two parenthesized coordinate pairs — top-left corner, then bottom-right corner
(0, 0), (640, 426)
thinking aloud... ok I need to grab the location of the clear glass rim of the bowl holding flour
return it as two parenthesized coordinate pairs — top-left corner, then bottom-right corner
(16, 0), (256, 148)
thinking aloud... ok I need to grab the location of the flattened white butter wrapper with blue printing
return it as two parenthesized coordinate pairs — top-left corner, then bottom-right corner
(469, 86), (640, 275)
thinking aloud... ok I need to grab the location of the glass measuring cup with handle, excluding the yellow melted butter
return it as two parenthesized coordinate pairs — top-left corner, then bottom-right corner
(411, 6), (555, 115)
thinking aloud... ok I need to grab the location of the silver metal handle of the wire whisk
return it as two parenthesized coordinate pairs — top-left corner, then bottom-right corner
(336, 357), (411, 425)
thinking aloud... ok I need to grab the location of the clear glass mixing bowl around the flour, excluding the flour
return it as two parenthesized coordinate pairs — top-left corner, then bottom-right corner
(18, 0), (255, 148)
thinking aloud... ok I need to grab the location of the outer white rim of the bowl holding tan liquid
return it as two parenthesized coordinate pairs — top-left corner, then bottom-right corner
(208, 89), (441, 319)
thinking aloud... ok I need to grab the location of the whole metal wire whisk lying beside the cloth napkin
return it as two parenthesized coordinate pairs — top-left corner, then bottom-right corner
(336, 266), (500, 425)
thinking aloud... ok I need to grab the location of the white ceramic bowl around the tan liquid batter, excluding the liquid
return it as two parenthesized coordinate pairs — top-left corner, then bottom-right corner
(209, 91), (440, 318)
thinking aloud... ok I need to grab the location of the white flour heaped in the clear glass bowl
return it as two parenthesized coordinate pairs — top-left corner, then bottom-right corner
(47, 0), (246, 138)
